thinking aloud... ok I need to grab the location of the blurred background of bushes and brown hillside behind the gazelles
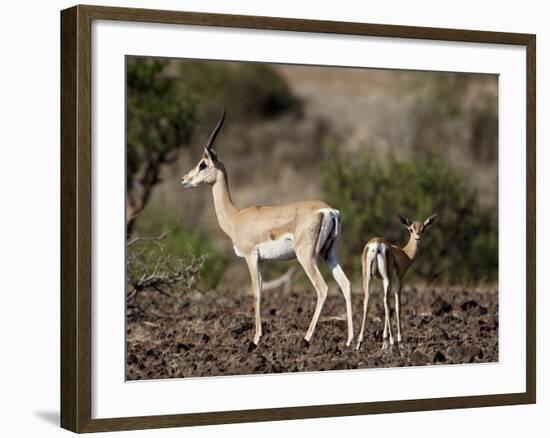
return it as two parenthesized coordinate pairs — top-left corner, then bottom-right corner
(127, 57), (498, 289)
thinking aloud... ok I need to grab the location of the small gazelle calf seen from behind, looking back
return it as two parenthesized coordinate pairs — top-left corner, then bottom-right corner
(357, 214), (437, 349)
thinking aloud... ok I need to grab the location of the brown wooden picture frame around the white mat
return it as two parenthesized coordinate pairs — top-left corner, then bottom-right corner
(61, 5), (536, 432)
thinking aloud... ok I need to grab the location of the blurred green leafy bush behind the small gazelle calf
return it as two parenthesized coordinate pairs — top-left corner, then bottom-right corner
(322, 151), (498, 283)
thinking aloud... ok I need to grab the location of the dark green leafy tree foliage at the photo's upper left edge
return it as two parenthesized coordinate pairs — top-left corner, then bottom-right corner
(126, 58), (201, 235)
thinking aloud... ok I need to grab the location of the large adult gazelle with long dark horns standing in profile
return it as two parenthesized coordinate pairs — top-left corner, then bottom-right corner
(181, 111), (353, 346)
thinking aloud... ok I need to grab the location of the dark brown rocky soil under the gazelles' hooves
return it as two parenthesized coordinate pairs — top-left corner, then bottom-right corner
(126, 287), (498, 380)
